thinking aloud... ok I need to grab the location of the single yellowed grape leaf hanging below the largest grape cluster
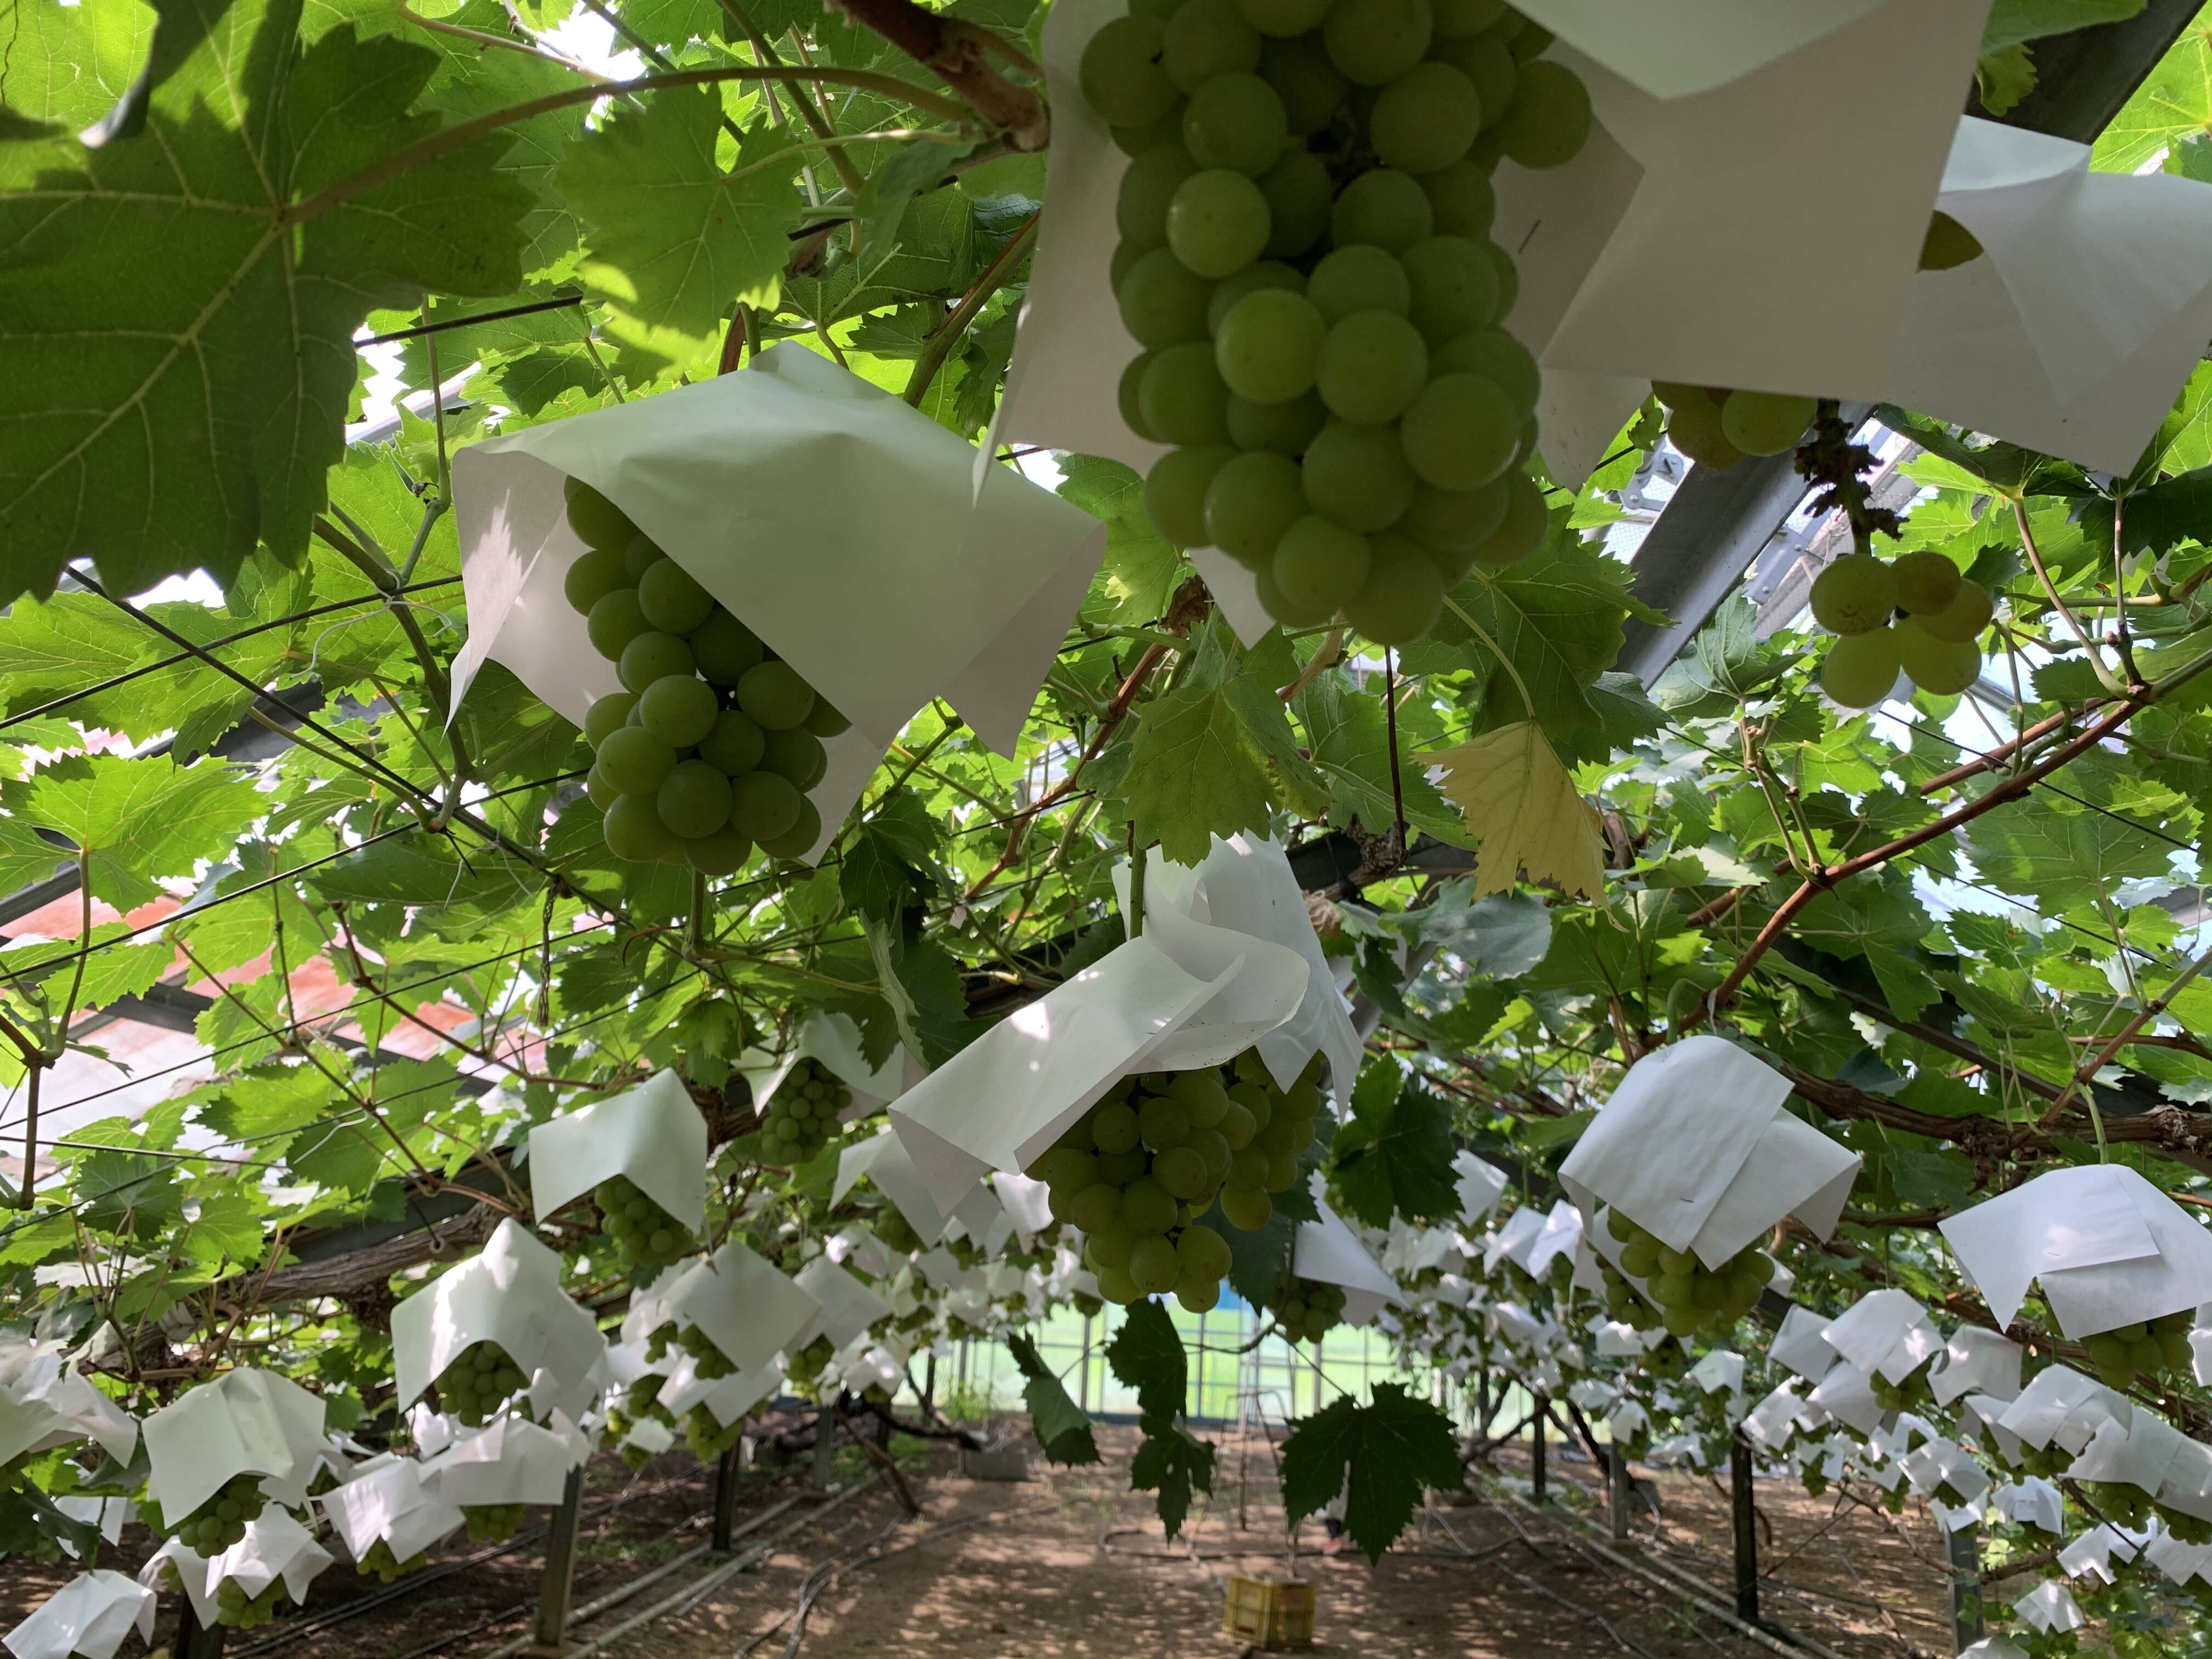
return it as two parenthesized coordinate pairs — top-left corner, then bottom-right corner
(1420, 721), (1606, 898)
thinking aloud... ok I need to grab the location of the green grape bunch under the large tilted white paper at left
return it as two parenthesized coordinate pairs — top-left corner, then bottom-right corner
(564, 478), (849, 876)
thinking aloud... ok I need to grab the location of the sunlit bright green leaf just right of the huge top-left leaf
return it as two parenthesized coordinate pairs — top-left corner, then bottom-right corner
(560, 86), (799, 338)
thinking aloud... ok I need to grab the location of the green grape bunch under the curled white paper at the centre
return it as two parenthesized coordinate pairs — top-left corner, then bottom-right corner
(1029, 1051), (1323, 1314)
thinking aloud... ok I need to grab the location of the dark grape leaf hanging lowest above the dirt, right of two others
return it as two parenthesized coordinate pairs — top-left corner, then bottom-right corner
(1283, 1383), (1466, 1562)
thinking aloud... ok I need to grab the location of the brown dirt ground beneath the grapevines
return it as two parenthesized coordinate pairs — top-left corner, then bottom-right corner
(13, 1420), (1951, 1659)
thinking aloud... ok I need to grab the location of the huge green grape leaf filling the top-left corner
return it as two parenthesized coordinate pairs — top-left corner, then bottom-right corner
(0, 0), (531, 602)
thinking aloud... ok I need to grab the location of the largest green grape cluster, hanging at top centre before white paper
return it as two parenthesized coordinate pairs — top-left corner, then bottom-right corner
(1082, 0), (1590, 646)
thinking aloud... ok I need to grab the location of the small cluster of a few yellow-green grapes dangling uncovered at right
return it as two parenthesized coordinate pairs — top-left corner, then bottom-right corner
(1812, 549), (1993, 708)
